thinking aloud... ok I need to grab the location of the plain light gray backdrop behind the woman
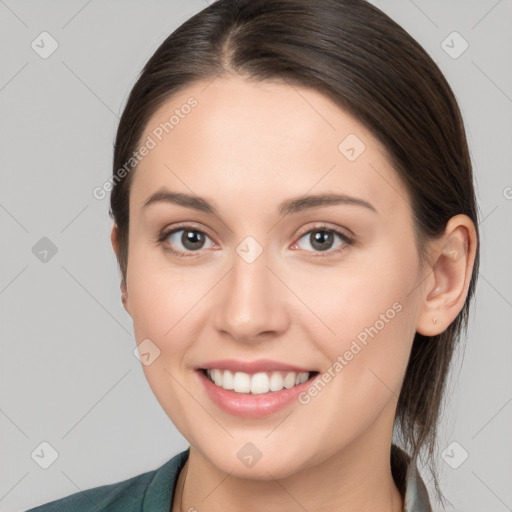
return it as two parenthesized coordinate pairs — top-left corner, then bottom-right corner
(0, 0), (512, 512)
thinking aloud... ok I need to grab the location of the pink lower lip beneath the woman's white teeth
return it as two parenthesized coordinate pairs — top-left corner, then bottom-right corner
(197, 370), (316, 418)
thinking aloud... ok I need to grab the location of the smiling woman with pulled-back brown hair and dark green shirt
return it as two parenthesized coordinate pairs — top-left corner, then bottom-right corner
(28, 0), (479, 512)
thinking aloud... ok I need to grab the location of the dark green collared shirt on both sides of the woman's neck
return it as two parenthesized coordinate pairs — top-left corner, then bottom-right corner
(27, 445), (432, 512)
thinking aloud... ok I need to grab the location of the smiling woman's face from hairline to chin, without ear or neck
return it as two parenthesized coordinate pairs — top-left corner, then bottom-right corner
(120, 77), (428, 478)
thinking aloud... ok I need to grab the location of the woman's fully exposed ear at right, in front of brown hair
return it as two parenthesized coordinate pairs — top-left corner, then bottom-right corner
(416, 214), (478, 336)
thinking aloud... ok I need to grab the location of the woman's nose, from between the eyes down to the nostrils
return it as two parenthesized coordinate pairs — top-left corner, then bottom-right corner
(215, 251), (290, 343)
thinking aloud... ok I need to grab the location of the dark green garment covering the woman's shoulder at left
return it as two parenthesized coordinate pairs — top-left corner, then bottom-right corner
(27, 448), (189, 512)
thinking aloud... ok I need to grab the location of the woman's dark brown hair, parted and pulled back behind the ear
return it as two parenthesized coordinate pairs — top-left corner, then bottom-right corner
(110, 0), (479, 504)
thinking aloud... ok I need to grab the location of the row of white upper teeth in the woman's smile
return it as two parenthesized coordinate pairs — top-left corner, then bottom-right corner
(206, 368), (311, 395)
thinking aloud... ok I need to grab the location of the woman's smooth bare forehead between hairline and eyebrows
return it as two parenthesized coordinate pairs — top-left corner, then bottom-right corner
(130, 76), (407, 217)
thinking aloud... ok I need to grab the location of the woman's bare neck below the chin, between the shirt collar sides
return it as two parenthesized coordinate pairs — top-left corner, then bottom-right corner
(172, 434), (403, 512)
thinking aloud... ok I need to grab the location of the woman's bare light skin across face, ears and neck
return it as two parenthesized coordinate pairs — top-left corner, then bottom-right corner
(112, 75), (476, 512)
